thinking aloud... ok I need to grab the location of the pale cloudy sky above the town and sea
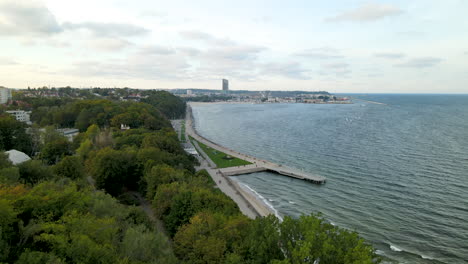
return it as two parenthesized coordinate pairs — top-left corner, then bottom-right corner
(0, 0), (468, 93)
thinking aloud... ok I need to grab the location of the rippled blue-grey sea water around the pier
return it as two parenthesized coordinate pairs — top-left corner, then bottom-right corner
(193, 95), (468, 263)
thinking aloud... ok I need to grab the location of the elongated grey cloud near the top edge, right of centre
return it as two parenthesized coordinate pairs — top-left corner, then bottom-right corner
(325, 3), (403, 22)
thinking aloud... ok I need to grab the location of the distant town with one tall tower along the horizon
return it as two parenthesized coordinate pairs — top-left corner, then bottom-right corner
(0, 79), (352, 110)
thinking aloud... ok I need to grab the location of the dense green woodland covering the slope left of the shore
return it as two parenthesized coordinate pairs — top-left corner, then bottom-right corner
(0, 89), (380, 264)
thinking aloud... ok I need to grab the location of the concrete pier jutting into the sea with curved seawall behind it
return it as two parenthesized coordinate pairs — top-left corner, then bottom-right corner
(185, 105), (326, 184)
